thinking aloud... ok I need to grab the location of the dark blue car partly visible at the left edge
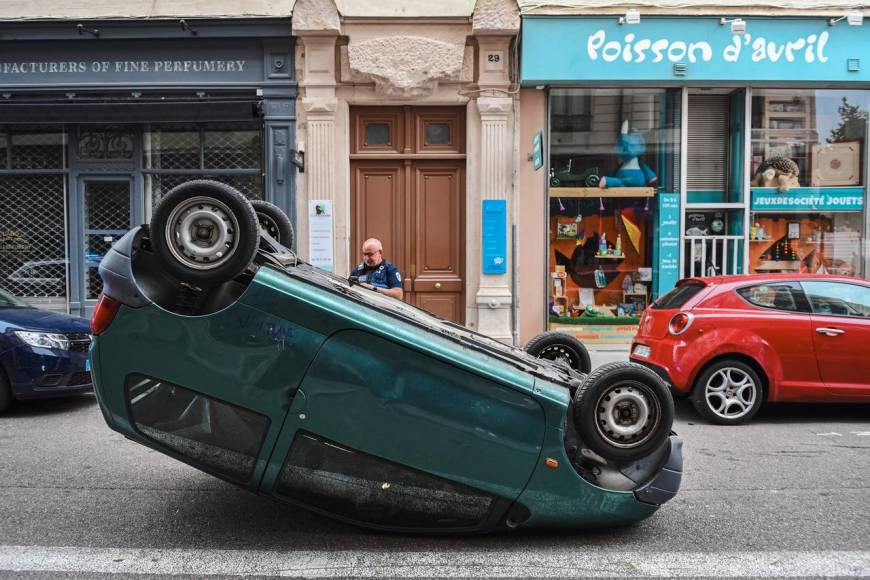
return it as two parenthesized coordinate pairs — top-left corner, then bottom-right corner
(0, 290), (94, 413)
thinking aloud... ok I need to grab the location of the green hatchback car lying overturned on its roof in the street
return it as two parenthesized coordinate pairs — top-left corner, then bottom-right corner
(91, 181), (682, 532)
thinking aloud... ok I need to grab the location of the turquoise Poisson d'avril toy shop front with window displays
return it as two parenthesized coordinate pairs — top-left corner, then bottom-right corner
(521, 15), (870, 345)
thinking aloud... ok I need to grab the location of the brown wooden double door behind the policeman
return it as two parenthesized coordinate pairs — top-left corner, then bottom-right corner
(350, 107), (465, 324)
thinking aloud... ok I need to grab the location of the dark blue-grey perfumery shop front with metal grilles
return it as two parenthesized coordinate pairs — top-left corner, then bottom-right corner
(0, 18), (296, 314)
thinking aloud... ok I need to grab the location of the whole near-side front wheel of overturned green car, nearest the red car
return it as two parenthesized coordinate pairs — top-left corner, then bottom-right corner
(573, 362), (674, 462)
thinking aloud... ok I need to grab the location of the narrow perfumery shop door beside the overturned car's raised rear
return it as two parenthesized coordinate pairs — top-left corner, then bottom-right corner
(84, 180), (130, 299)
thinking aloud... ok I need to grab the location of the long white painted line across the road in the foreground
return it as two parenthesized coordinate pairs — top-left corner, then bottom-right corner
(0, 546), (870, 578)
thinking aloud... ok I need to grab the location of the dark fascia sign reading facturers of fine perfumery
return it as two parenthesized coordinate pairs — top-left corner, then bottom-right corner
(0, 39), (263, 86)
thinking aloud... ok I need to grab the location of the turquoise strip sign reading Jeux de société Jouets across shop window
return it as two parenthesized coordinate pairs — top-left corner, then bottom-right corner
(751, 187), (864, 212)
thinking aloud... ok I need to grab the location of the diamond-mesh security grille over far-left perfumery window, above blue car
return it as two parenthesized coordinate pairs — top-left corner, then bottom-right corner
(0, 127), (68, 310)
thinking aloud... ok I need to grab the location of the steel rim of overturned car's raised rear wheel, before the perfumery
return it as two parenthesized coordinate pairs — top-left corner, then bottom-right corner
(165, 196), (239, 270)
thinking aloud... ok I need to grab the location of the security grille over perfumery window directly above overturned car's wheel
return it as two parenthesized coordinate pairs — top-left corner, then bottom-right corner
(143, 123), (264, 219)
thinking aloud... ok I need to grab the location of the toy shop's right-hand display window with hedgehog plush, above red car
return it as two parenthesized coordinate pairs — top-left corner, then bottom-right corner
(749, 89), (870, 276)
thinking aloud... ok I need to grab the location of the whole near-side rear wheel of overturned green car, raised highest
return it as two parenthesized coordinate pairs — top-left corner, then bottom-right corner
(150, 180), (260, 286)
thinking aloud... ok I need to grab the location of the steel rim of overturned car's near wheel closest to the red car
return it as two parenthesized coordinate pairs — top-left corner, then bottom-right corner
(595, 381), (662, 449)
